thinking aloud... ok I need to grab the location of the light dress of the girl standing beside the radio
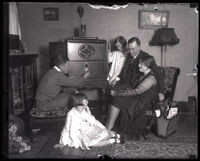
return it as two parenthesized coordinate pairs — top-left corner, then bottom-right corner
(107, 51), (126, 84)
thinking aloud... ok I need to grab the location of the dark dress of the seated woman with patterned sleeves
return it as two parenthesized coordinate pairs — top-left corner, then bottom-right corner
(112, 71), (158, 134)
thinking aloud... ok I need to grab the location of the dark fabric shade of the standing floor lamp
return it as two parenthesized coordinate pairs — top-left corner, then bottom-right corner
(149, 28), (179, 46)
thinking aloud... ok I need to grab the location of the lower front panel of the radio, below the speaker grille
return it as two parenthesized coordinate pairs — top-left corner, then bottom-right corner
(69, 62), (106, 80)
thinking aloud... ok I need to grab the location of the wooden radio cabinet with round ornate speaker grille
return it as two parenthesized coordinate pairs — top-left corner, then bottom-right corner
(49, 39), (108, 88)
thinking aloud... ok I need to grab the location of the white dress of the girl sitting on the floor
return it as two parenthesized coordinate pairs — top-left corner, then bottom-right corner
(59, 107), (109, 149)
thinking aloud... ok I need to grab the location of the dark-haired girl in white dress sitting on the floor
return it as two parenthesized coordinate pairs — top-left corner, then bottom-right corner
(55, 93), (120, 150)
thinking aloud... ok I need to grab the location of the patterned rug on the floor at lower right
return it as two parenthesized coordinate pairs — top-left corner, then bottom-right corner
(111, 133), (198, 159)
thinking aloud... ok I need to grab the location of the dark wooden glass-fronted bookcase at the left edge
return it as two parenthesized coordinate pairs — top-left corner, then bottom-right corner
(9, 54), (38, 138)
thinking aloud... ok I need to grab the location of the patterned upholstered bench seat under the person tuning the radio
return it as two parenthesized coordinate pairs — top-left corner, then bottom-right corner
(30, 107), (69, 118)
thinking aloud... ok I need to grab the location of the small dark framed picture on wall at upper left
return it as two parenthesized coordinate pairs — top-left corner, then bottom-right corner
(43, 8), (59, 21)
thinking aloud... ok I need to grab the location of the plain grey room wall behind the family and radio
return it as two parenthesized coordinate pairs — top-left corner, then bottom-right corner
(18, 2), (199, 101)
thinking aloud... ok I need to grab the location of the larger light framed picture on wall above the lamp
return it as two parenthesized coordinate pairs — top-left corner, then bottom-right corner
(138, 10), (169, 29)
